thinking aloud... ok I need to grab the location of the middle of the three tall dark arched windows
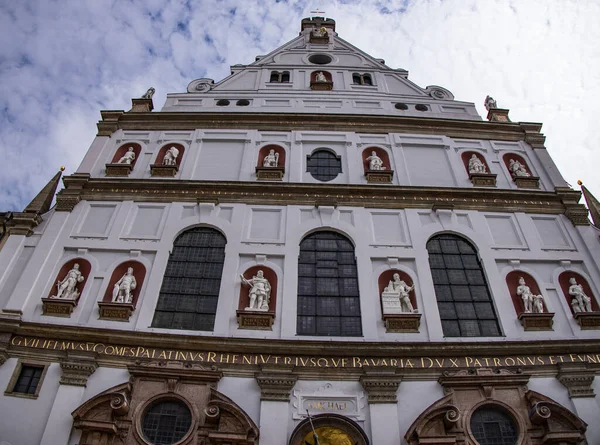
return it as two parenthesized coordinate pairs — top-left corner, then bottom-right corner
(298, 231), (362, 336)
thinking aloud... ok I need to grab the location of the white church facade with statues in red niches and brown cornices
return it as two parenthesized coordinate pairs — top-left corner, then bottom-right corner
(0, 17), (600, 445)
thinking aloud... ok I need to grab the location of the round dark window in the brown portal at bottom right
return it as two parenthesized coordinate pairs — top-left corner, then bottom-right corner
(471, 406), (518, 445)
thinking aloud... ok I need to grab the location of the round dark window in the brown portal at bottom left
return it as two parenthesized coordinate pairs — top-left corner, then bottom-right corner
(142, 400), (192, 445)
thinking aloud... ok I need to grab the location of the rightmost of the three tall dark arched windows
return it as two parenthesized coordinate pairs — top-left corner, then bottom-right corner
(427, 233), (502, 337)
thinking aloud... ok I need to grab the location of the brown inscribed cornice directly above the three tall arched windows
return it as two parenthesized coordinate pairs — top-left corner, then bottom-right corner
(57, 175), (589, 224)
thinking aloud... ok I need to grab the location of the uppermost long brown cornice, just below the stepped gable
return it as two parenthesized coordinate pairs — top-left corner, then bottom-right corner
(98, 110), (543, 141)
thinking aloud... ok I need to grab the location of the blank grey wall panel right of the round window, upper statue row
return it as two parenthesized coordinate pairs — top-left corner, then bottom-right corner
(404, 147), (456, 187)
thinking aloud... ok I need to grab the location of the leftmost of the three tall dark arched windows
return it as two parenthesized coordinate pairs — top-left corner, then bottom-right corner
(152, 227), (227, 331)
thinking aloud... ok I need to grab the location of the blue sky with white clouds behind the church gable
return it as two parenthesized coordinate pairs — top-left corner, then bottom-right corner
(0, 0), (600, 211)
